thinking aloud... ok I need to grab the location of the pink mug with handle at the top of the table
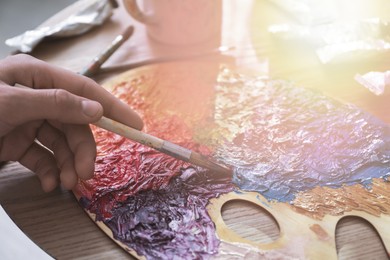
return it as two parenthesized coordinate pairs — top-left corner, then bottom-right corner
(123, 0), (222, 45)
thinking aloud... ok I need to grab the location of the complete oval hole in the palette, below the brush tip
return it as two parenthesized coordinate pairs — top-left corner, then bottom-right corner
(221, 200), (280, 244)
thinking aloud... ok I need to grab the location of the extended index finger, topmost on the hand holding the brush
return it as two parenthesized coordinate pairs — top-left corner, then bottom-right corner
(0, 54), (143, 129)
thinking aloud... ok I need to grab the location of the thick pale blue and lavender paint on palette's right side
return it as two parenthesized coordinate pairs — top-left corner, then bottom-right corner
(215, 75), (390, 203)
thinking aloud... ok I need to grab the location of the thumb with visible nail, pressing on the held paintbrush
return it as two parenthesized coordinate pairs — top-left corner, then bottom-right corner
(0, 87), (103, 126)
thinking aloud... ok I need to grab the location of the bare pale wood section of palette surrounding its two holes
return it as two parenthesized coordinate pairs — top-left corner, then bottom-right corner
(208, 192), (390, 259)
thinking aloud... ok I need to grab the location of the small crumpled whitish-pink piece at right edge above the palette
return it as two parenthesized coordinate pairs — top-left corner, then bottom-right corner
(355, 71), (390, 96)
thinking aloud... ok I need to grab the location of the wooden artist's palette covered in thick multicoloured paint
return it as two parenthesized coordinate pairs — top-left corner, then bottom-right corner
(75, 62), (390, 259)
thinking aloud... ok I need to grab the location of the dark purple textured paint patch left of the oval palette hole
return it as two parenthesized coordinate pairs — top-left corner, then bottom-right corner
(80, 168), (233, 259)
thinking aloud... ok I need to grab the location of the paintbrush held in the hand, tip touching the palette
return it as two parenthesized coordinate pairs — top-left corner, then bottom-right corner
(94, 117), (233, 176)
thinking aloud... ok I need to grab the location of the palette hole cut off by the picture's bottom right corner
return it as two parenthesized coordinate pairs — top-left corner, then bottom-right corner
(336, 216), (389, 260)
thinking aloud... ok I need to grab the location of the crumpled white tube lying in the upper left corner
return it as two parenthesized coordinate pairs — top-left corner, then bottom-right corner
(5, 0), (113, 52)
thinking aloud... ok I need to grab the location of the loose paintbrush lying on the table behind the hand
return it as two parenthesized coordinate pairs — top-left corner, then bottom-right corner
(80, 25), (134, 77)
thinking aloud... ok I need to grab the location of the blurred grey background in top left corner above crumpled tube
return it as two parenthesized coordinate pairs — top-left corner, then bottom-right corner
(0, 0), (76, 59)
